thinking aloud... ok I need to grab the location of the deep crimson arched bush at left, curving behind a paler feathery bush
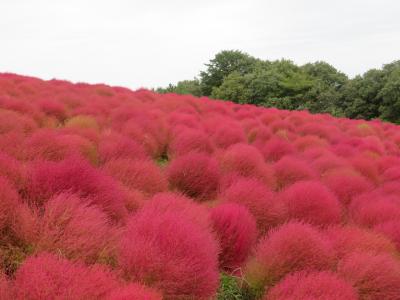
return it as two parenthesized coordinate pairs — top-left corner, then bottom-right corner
(26, 158), (127, 221)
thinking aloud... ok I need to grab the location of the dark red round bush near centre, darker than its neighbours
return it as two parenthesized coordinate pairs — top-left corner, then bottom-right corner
(167, 153), (220, 200)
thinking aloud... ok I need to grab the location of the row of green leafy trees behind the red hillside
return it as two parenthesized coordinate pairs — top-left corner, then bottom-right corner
(156, 50), (400, 123)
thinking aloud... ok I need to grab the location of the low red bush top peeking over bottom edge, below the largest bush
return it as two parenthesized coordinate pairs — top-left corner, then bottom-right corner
(107, 283), (162, 300)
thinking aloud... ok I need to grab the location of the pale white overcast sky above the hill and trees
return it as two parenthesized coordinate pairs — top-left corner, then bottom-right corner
(0, 0), (400, 88)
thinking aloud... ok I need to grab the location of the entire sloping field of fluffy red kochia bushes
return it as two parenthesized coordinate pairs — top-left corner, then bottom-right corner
(0, 74), (400, 300)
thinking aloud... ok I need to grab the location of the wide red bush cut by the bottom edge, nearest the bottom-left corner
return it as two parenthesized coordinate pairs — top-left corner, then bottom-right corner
(14, 253), (118, 300)
